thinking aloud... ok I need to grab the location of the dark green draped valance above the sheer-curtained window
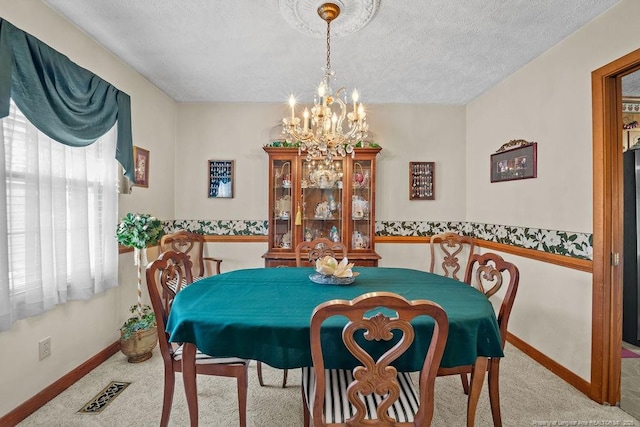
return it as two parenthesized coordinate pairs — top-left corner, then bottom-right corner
(0, 18), (134, 181)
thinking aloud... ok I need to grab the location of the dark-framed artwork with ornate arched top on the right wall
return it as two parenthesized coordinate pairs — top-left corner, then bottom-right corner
(491, 139), (538, 182)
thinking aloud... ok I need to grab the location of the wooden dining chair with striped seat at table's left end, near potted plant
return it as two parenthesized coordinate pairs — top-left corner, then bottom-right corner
(146, 251), (249, 427)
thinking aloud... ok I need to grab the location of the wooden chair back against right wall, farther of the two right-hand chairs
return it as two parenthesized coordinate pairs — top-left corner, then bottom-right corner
(429, 232), (475, 280)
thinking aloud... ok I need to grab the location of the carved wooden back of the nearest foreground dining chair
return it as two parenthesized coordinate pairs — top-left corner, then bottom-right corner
(305, 292), (449, 426)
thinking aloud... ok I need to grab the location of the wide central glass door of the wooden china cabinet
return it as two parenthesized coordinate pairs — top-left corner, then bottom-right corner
(300, 160), (344, 247)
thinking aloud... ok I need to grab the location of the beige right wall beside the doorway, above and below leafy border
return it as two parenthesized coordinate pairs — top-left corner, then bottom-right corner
(466, 0), (640, 380)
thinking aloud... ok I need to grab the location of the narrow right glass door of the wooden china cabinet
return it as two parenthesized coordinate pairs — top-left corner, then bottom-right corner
(349, 160), (373, 251)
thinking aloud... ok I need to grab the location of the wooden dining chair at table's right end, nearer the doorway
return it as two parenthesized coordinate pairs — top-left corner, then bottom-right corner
(438, 252), (520, 427)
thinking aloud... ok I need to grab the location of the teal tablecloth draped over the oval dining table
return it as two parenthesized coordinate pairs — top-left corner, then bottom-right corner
(167, 267), (503, 371)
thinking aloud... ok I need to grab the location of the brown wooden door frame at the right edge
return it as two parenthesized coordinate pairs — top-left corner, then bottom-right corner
(590, 49), (640, 405)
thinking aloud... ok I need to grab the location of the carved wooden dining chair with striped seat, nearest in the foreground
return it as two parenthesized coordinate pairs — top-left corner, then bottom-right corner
(302, 292), (449, 427)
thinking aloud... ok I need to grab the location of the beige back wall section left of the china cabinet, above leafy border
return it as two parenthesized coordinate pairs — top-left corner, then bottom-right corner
(175, 104), (281, 221)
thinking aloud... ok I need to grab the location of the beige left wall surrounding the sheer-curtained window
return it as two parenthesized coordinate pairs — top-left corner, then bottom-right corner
(0, 0), (176, 416)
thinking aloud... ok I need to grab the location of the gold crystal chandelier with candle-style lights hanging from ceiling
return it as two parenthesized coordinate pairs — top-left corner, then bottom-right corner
(282, 3), (369, 163)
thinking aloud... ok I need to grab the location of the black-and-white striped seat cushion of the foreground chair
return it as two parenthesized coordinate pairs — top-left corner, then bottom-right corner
(302, 368), (419, 423)
